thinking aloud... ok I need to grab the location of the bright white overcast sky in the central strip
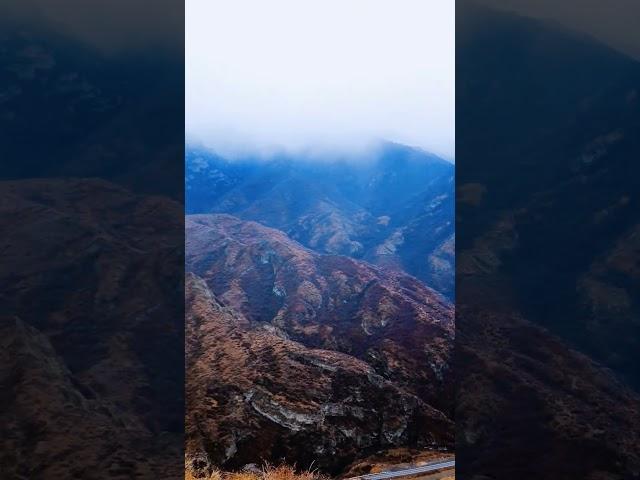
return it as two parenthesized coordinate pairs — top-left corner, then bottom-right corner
(185, 0), (455, 158)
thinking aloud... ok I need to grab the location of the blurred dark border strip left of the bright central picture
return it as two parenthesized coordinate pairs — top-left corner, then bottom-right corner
(0, 0), (184, 479)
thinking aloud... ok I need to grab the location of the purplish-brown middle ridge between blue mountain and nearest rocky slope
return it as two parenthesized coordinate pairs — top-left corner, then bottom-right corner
(186, 215), (454, 410)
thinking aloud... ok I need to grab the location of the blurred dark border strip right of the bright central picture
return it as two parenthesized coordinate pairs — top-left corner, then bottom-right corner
(456, 0), (640, 480)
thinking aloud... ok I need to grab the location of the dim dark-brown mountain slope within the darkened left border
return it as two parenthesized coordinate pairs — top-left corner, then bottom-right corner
(0, 179), (184, 479)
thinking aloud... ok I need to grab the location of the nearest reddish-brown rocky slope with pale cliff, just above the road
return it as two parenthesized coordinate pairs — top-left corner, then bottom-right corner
(186, 275), (452, 471)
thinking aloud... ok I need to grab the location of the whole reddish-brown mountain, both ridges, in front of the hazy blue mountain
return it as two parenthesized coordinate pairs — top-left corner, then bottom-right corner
(186, 215), (454, 474)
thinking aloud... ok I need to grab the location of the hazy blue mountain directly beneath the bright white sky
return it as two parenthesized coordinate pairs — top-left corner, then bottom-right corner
(185, 144), (454, 298)
